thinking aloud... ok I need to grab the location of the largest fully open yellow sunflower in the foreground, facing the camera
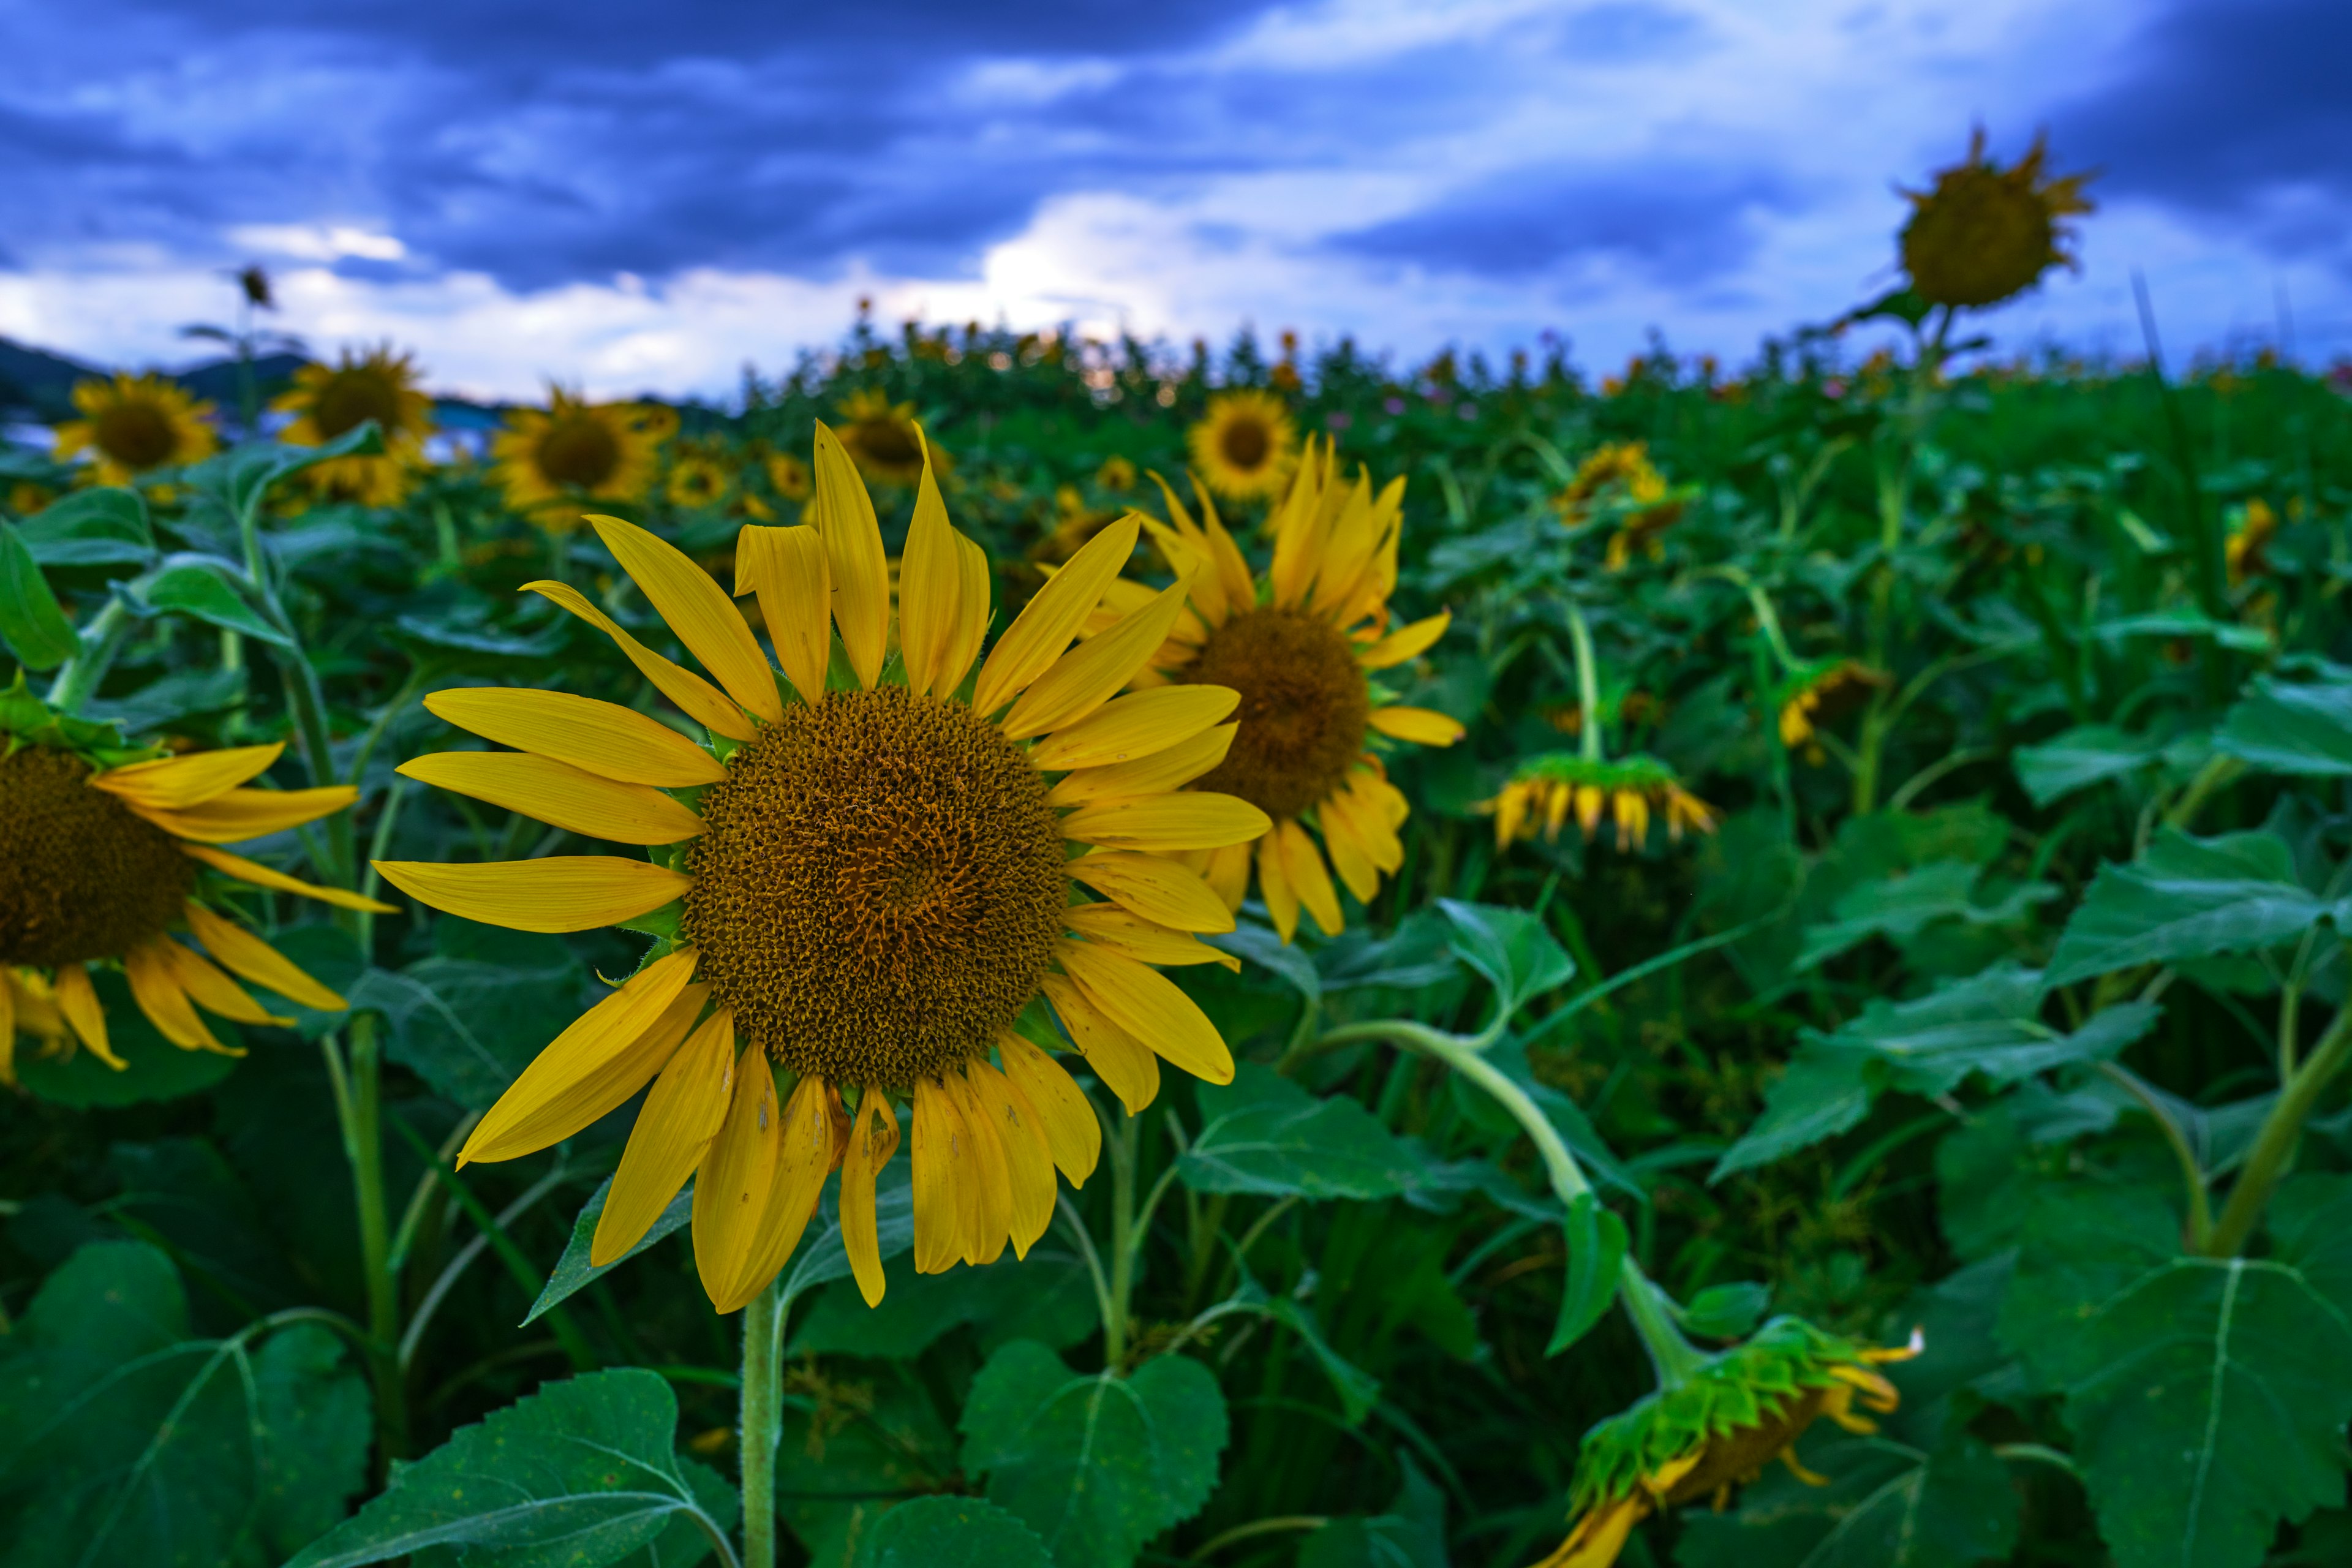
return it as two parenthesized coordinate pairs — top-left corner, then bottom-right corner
(381, 426), (1265, 1312)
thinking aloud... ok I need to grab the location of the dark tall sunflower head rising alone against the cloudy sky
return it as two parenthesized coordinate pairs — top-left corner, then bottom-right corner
(1901, 127), (2091, 308)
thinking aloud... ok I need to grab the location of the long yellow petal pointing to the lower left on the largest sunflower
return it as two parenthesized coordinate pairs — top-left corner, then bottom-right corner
(456, 950), (696, 1166)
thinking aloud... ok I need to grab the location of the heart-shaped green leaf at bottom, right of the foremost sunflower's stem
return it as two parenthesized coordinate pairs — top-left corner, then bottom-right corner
(962, 1340), (1227, 1568)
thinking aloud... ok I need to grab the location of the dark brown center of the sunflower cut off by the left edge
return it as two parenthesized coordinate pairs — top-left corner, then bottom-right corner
(0, 745), (195, 968)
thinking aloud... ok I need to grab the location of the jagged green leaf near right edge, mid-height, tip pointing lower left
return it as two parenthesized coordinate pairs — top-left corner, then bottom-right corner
(2046, 827), (2329, 985)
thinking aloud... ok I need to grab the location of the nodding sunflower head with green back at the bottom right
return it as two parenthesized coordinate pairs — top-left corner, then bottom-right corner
(1536, 1316), (1921, 1568)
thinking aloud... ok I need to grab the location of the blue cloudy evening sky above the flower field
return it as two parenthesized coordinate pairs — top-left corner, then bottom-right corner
(0, 0), (2352, 395)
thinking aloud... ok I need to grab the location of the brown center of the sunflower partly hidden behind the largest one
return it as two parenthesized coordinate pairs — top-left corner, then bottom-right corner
(1185, 609), (1371, 818)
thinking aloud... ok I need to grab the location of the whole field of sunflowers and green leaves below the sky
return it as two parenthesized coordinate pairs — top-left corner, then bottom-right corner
(0, 138), (2352, 1568)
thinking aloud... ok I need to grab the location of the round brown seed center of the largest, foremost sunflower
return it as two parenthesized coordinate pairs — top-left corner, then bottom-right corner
(684, 687), (1068, 1088)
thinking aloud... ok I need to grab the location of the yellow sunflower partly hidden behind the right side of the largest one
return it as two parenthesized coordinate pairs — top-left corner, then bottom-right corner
(1096, 440), (1463, 940)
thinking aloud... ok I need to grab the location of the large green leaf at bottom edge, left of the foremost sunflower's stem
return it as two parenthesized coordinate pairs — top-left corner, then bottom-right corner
(287, 1366), (717, 1568)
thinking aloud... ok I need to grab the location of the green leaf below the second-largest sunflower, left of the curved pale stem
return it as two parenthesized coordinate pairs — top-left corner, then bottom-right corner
(1176, 1063), (1423, 1199)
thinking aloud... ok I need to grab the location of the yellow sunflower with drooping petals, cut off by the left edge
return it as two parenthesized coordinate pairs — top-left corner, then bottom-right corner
(0, 675), (388, 1082)
